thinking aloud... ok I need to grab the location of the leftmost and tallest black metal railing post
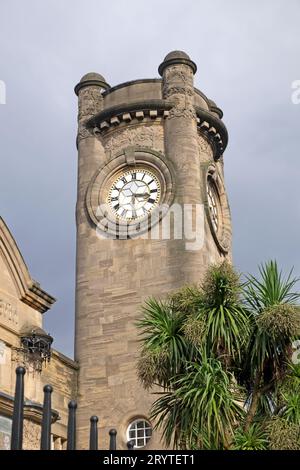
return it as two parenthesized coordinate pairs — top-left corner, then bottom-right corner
(10, 366), (26, 450)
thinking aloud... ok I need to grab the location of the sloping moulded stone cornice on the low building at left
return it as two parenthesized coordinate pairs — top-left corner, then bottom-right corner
(0, 217), (55, 313)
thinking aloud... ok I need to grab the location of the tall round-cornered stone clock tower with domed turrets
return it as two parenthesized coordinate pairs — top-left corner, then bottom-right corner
(75, 51), (231, 449)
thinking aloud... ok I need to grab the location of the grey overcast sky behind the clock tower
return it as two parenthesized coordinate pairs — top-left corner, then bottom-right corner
(0, 0), (300, 355)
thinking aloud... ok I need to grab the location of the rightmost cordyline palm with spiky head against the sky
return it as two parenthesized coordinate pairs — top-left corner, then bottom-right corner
(239, 261), (300, 431)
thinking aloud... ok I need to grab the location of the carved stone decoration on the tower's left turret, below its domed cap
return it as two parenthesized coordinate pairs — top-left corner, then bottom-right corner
(78, 86), (103, 139)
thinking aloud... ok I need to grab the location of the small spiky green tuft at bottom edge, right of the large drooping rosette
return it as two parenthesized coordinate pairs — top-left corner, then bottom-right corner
(233, 423), (268, 450)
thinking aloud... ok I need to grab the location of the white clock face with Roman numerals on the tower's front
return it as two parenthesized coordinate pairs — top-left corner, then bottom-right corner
(108, 168), (160, 220)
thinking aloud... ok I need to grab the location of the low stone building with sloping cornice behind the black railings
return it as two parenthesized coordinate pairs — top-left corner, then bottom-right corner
(0, 218), (78, 449)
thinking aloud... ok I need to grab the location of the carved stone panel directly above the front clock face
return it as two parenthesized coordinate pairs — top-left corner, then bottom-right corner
(103, 124), (164, 156)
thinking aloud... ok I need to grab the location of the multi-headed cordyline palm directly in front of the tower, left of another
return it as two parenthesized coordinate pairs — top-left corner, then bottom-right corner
(138, 263), (250, 448)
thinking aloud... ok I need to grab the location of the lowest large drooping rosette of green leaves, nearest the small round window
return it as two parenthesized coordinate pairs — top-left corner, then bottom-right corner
(152, 357), (243, 449)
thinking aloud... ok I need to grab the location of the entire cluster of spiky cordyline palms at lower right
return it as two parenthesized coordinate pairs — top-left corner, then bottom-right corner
(137, 262), (300, 450)
